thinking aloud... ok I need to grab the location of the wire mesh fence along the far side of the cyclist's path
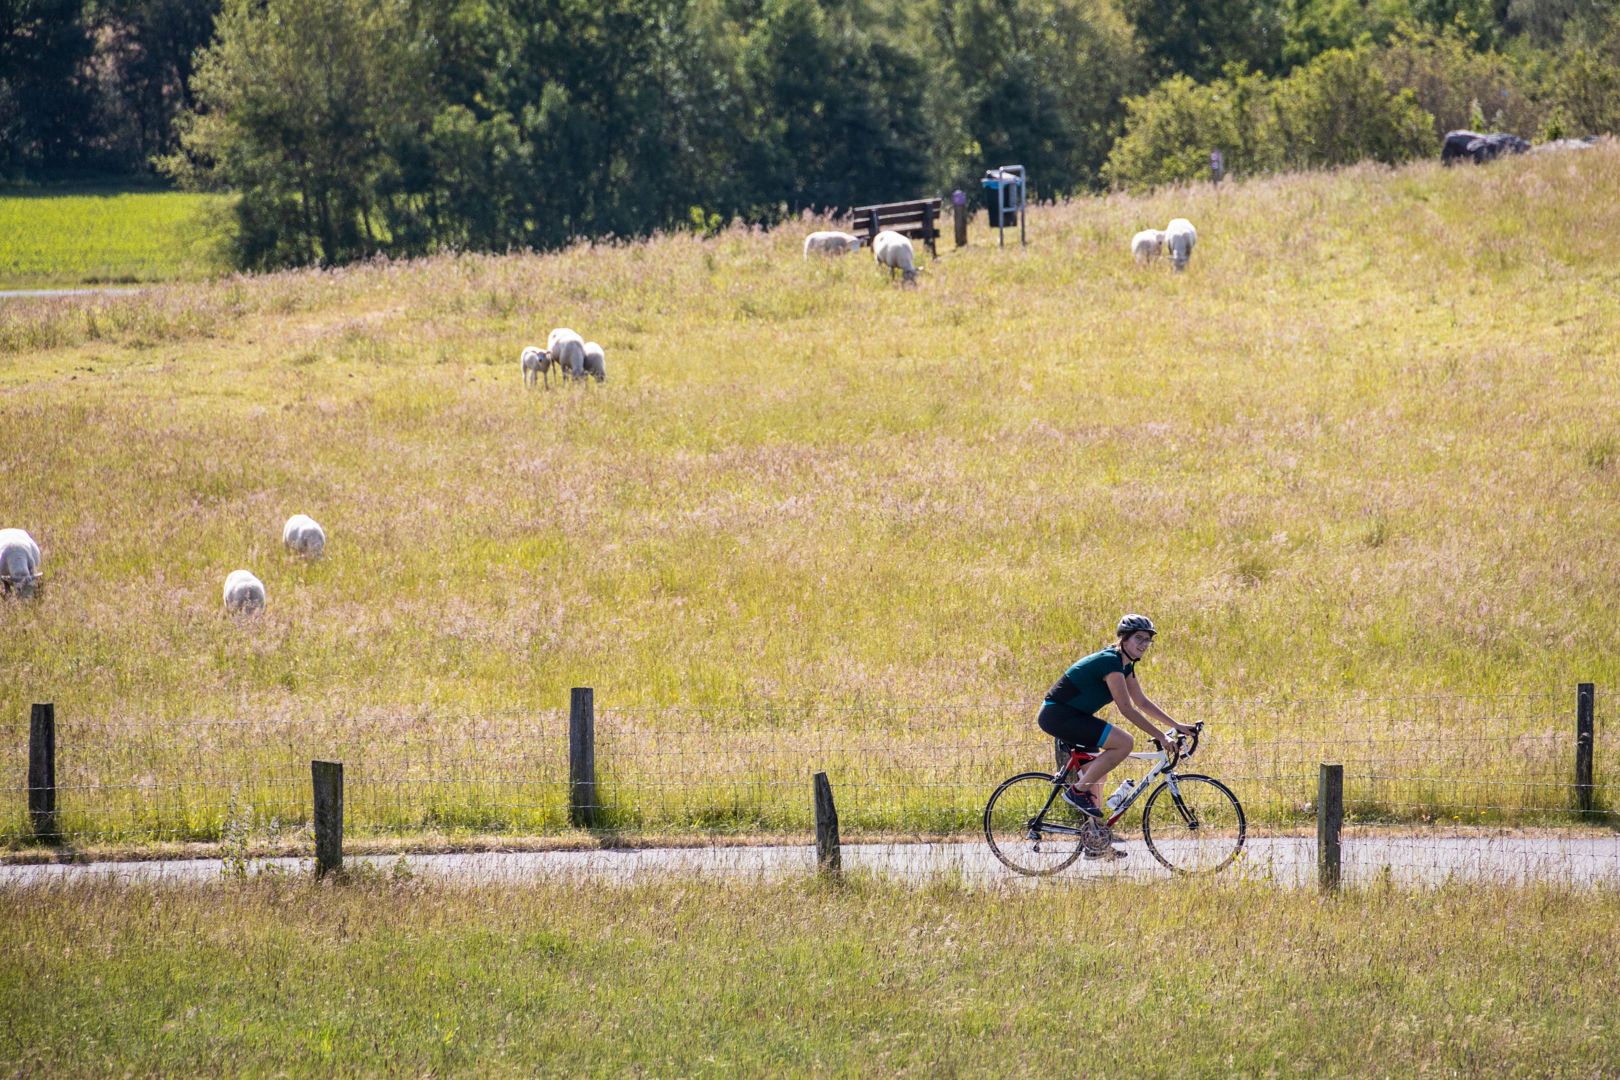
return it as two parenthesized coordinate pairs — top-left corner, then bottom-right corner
(0, 691), (1620, 876)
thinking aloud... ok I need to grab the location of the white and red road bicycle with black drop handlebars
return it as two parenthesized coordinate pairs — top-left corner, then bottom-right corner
(985, 724), (1246, 878)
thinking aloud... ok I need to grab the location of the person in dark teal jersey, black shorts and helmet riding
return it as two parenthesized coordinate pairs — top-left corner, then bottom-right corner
(1035, 615), (1194, 819)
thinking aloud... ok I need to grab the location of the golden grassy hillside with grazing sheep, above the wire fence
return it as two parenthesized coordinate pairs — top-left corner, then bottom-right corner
(0, 144), (1620, 735)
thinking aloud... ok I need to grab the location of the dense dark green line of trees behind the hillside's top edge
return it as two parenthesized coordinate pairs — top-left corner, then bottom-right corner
(0, 0), (1620, 269)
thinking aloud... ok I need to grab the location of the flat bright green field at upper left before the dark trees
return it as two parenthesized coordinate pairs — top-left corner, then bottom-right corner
(0, 191), (230, 288)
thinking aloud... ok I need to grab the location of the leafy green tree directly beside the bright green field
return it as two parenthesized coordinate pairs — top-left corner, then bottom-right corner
(164, 0), (433, 269)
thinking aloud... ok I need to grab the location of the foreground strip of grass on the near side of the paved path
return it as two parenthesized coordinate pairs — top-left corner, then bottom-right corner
(0, 878), (1620, 1080)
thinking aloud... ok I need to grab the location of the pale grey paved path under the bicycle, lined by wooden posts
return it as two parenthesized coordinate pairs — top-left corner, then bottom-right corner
(0, 837), (1620, 889)
